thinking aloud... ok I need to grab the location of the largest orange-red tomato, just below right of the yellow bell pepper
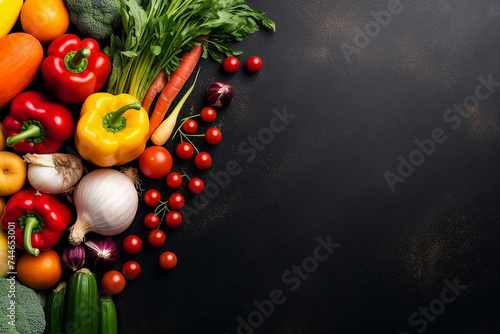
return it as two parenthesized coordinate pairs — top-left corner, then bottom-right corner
(139, 146), (172, 179)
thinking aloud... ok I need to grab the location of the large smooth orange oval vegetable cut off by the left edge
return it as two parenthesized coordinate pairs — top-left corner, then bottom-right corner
(0, 32), (43, 109)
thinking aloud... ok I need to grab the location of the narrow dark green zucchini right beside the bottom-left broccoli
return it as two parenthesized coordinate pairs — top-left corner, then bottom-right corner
(45, 282), (67, 334)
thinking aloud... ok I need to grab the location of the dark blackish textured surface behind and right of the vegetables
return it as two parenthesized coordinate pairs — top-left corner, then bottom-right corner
(2, 0), (500, 334)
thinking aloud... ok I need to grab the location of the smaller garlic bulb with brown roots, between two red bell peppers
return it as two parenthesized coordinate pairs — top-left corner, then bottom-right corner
(24, 153), (83, 194)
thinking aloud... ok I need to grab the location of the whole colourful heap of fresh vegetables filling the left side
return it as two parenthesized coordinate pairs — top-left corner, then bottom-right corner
(0, 0), (275, 334)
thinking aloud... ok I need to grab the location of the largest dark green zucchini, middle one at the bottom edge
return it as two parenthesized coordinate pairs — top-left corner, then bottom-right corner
(65, 268), (99, 334)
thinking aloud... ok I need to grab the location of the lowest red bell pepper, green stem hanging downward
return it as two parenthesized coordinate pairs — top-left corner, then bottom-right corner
(2, 189), (73, 256)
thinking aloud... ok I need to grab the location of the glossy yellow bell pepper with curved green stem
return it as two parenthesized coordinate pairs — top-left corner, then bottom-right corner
(75, 93), (149, 167)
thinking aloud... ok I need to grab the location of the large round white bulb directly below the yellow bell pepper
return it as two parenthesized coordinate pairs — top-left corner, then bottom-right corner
(69, 168), (139, 246)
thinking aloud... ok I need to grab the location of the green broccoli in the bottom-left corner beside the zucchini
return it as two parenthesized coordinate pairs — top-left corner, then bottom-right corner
(0, 277), (45, 334)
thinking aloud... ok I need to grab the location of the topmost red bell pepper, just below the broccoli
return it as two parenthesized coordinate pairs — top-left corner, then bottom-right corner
(42, 34), (111, 104)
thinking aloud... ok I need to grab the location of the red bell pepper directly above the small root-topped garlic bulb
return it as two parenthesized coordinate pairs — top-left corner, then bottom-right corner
(3, 92), (75, 153)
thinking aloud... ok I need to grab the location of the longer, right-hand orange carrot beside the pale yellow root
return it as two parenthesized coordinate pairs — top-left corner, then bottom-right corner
(148, 36), (207, 136)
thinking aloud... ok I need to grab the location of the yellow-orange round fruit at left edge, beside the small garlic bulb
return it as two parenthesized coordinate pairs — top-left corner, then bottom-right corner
(0, 151), (27, 196)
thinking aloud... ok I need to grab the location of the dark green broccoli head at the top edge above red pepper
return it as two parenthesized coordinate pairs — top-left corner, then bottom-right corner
(66, 0), (128, 40)
